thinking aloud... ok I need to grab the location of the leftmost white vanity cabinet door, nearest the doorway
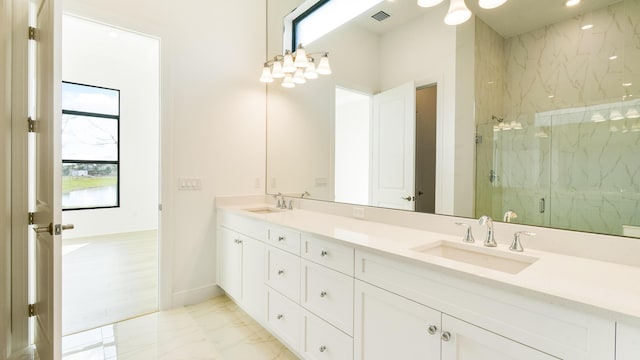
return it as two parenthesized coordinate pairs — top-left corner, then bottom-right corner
(218, 227), (242, 301)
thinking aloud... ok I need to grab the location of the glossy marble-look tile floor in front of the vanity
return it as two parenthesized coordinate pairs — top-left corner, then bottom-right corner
(62, 296), (298, 360)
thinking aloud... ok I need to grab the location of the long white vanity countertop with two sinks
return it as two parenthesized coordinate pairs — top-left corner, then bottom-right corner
(218, 204), (640, 325)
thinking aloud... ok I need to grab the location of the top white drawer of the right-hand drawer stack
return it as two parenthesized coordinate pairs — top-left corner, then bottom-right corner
(302, 235), (354, 276)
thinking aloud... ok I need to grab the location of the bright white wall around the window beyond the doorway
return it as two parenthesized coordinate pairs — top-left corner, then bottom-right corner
(62, 15), (160, 239)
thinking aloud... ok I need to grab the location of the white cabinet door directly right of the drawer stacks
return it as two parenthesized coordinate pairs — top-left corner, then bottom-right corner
(354, 280), (440, 360)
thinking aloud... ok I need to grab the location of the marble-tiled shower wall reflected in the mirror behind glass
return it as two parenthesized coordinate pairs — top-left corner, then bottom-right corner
(476, 0), (640, 235)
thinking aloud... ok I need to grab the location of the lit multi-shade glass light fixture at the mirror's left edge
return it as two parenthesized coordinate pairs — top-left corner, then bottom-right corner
(260, 44), (331, 88)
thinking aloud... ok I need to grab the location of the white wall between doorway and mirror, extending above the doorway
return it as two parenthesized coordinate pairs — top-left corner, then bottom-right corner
(64, 0), (266, 307)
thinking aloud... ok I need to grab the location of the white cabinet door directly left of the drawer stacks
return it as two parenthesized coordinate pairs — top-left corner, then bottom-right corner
(241, 237), (267, 322)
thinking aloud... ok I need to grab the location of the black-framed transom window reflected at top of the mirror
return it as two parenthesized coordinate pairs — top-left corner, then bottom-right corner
(285, 0), (383, 51)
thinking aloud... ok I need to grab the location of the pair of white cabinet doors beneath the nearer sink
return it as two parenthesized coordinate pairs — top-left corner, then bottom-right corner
(354, 281), (557, 360)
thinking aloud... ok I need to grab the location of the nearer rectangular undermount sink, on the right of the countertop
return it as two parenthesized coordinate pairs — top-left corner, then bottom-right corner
(411, 240), (538, 274)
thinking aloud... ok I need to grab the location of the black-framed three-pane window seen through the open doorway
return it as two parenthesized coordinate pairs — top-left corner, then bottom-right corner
(61, 82), (120, 210)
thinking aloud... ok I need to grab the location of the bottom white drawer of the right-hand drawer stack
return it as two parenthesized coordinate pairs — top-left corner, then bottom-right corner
(300, 310), (353, 360)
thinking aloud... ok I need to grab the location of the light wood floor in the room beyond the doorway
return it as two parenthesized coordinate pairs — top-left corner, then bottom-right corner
(62, 231), (158, 335)
